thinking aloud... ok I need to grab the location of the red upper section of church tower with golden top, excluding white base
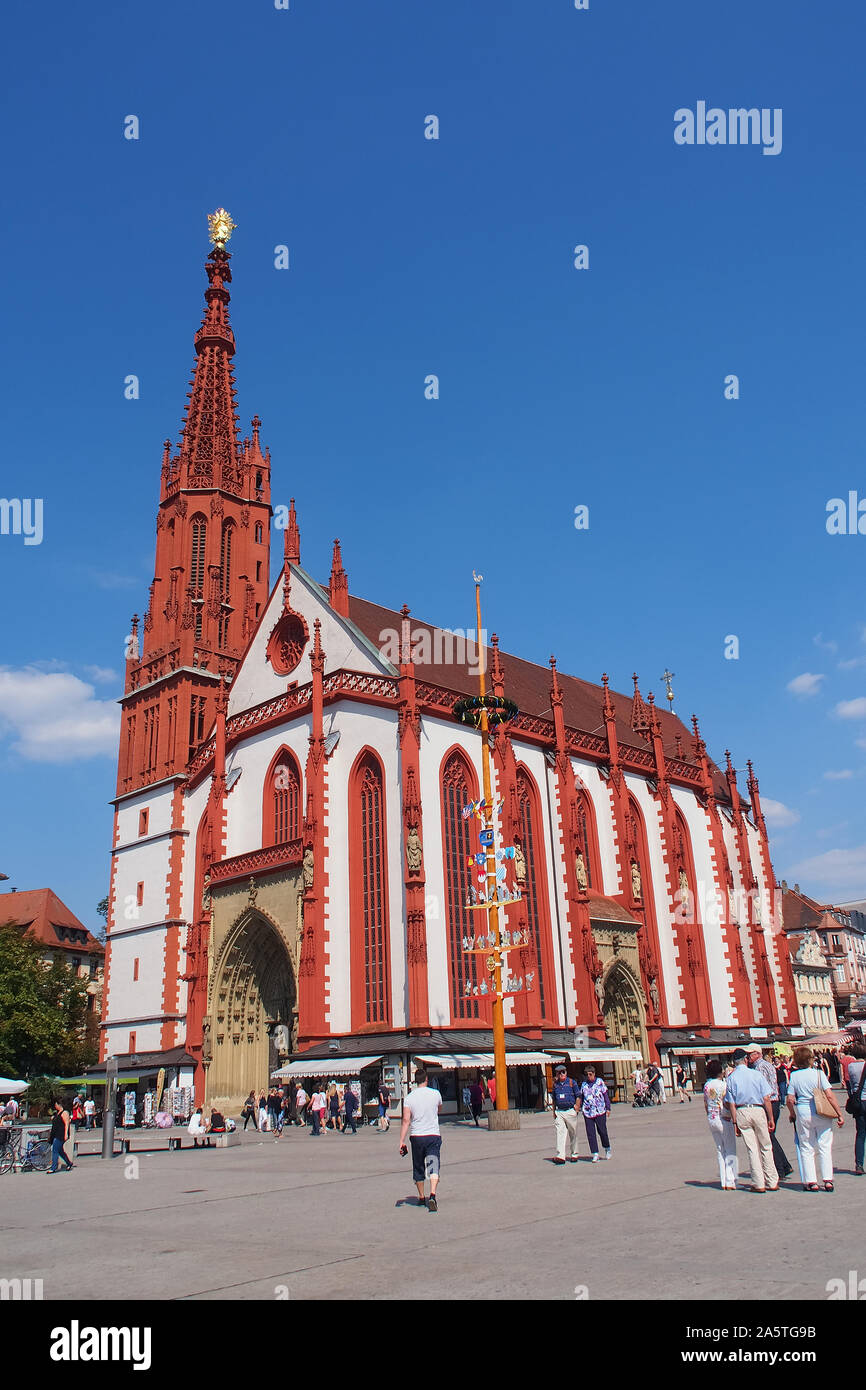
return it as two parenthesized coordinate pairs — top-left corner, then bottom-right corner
(117, 209), (271, 796)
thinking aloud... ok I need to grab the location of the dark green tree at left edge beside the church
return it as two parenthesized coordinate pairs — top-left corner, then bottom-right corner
(0, 924), (96, 1077)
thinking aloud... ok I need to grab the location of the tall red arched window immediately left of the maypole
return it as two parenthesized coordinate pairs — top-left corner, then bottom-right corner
(442, 752), (484, 1022)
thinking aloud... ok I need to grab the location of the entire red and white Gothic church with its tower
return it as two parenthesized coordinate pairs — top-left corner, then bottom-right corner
(101, 225), (798, 1104)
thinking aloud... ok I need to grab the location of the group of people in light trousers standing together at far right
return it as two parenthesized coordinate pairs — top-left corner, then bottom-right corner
(703, 1044), (866, 1193)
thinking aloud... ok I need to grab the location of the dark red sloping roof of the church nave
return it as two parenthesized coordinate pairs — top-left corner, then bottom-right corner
(347, 595), (748, 809)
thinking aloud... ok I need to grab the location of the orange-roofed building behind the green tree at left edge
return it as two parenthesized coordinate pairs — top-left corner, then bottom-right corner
(0, 888), (106, 1047)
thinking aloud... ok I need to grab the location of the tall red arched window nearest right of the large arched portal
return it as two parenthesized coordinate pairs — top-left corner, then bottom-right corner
(349, 753), (391, 1023)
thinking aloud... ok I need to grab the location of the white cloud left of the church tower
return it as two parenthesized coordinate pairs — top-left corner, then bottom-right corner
(0, 666), (120, 763)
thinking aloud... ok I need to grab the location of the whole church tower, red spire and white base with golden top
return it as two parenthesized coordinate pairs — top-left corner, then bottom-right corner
(101, 209), (271, 1058)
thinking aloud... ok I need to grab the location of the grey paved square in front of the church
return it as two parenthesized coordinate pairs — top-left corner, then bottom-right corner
(0, 1099), (866, 1301)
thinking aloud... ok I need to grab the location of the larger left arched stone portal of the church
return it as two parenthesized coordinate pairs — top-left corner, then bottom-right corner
(207, 908), (296, 1105)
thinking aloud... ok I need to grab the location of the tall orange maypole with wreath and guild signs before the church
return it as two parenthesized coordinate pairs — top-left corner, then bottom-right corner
(453, 571), (535, 1129)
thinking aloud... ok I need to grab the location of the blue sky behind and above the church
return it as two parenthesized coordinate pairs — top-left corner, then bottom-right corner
(0, 0), (866, 924)
